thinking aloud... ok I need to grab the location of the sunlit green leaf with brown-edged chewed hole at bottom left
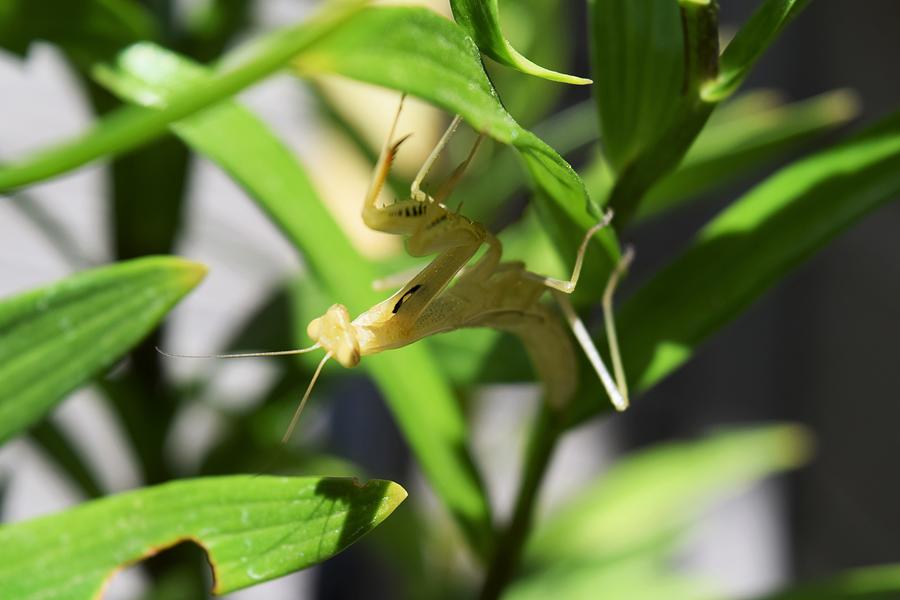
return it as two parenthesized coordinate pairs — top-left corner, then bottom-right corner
(0, 475), (406, 600)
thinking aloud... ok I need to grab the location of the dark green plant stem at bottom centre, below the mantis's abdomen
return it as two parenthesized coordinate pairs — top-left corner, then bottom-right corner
(479, 405), (563, 600)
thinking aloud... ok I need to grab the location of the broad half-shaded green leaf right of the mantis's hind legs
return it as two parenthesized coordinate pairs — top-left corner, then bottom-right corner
(618, 113), (900, 389)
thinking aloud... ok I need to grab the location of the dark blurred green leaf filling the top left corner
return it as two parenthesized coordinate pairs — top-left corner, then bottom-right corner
(0, 0), (158, 69)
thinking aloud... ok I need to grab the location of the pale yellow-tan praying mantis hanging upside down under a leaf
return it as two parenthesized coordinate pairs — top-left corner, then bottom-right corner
(167, 98), (633, 442)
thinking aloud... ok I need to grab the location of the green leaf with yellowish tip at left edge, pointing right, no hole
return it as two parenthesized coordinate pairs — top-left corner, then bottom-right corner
(0, 257), (205, 442)
